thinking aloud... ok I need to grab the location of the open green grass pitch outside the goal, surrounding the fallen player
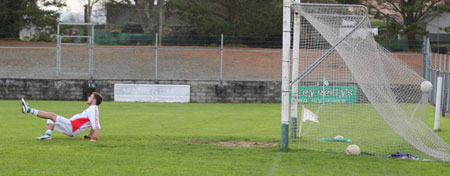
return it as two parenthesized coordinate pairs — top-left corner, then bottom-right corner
(0, 101), (450, 175)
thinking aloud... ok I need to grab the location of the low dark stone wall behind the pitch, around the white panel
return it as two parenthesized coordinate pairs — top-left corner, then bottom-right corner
(0, 79), (281, 103)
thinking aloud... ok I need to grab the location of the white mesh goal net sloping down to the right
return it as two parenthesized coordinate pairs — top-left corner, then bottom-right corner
(289, 3), (450, 161)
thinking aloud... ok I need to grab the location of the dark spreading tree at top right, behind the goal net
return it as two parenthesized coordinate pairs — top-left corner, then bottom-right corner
(364, 0), (450, 49)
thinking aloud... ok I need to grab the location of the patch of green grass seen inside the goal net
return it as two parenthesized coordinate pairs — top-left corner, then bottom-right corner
(290, 104), (435, 160)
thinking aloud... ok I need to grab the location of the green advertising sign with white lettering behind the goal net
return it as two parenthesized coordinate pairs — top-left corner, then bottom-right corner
(298, 86), (358, 103)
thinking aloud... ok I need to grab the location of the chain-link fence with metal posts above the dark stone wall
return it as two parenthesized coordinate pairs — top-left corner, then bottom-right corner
(0, 32), (424, 81)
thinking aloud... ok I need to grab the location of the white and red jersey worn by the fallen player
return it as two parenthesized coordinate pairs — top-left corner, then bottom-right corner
(69, 105), (100, 136)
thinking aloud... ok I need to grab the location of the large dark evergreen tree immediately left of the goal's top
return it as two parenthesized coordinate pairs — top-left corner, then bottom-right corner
(169, 0), (282, 36)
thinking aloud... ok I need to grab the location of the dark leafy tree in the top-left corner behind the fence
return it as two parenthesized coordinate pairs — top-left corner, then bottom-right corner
(0, 0), (65, 38)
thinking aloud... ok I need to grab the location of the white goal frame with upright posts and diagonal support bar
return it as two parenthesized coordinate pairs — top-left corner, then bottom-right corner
(281, 0), (368, 150)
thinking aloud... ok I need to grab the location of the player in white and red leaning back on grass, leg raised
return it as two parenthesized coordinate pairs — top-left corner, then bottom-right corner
(22, 92), (103, 141)
